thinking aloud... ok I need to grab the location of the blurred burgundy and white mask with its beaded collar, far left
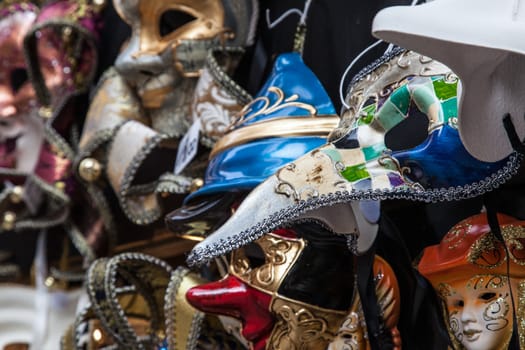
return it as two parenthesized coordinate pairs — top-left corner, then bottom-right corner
(0, 0), (104, 274)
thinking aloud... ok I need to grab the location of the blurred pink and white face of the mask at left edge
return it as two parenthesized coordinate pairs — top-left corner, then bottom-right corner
(0, 3), (42, 172)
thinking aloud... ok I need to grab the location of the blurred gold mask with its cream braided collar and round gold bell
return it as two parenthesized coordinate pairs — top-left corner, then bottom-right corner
(76, 0), (257, 225)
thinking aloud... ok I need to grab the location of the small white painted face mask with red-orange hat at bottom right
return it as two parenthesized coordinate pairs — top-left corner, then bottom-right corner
(418, 214), (525, 350)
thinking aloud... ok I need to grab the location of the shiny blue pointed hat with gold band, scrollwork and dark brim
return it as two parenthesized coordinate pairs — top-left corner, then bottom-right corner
(166, 53), (339, 239)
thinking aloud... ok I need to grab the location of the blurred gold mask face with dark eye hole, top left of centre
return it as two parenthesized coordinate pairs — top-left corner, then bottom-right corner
(114, 0), (257, 133)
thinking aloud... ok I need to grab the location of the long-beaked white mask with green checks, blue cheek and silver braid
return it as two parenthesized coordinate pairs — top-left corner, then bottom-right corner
(188, 49), (518, 264)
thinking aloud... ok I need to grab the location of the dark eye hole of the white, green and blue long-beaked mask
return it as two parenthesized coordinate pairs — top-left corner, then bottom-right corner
(385, 107), (428, 151)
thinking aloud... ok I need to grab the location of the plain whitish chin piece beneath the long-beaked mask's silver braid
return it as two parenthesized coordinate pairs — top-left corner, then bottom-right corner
(298, 201), (379, 255)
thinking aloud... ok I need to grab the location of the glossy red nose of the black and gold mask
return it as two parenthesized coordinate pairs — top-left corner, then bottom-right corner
(186, 276), (273, 341)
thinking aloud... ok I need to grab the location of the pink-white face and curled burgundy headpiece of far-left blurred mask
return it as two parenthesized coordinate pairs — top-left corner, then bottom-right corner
(0, 1), (98, 182)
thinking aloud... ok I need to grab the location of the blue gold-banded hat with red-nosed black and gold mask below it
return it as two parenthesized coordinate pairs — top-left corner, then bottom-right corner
(167, 46), (399, 349)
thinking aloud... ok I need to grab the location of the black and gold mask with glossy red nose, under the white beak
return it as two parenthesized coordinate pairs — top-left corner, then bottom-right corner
(186, 224), (399, 350)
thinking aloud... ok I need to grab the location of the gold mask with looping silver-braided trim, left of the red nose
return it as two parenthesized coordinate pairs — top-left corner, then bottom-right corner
(61, 253), (244, 350)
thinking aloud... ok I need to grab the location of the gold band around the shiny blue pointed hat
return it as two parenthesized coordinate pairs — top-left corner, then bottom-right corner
(210, 114), (339, 159)
